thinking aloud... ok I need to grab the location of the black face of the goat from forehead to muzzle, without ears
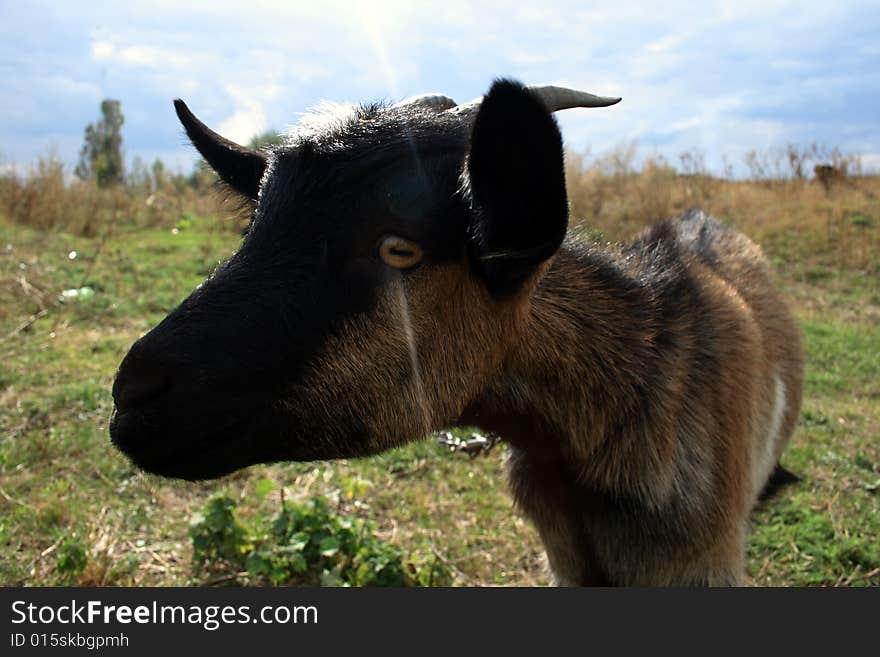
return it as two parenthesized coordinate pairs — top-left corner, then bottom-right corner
(110, 121), (466, 479)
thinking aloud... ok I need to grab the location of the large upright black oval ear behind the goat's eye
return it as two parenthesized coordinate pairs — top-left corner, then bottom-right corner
(466, 80), (568, 298)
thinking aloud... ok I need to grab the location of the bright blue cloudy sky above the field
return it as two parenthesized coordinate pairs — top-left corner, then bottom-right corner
(0, 0), (880, 177)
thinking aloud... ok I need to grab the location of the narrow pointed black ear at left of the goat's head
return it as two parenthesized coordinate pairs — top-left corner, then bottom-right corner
(174, 98), (266, 201)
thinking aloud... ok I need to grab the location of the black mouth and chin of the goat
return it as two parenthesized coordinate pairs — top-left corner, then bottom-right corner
(109, 408), (265, 481)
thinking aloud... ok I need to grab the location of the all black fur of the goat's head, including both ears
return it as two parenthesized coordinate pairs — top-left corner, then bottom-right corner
(110, 83), (566, 479)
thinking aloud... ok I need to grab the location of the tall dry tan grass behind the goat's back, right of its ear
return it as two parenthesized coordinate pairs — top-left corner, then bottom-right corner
(567, 148), (880, 273)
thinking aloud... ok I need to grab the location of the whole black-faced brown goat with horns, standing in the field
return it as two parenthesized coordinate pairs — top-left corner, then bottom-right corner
(110, 80), (803, 585)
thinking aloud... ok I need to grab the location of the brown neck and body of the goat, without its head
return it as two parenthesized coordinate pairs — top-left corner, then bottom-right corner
(462, 211), (803, 585)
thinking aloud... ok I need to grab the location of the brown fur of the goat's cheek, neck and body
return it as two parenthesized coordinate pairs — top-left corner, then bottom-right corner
(300, 213), (802, 585)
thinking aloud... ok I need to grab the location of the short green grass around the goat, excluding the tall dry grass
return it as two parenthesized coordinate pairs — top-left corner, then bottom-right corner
(0, 217), (880, 585)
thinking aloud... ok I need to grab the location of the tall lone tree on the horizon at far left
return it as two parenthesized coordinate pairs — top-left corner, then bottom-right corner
(74, 98), (125, 187)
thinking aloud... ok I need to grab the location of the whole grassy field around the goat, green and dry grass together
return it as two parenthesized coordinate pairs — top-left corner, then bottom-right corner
(0, 158), (880, 586)
